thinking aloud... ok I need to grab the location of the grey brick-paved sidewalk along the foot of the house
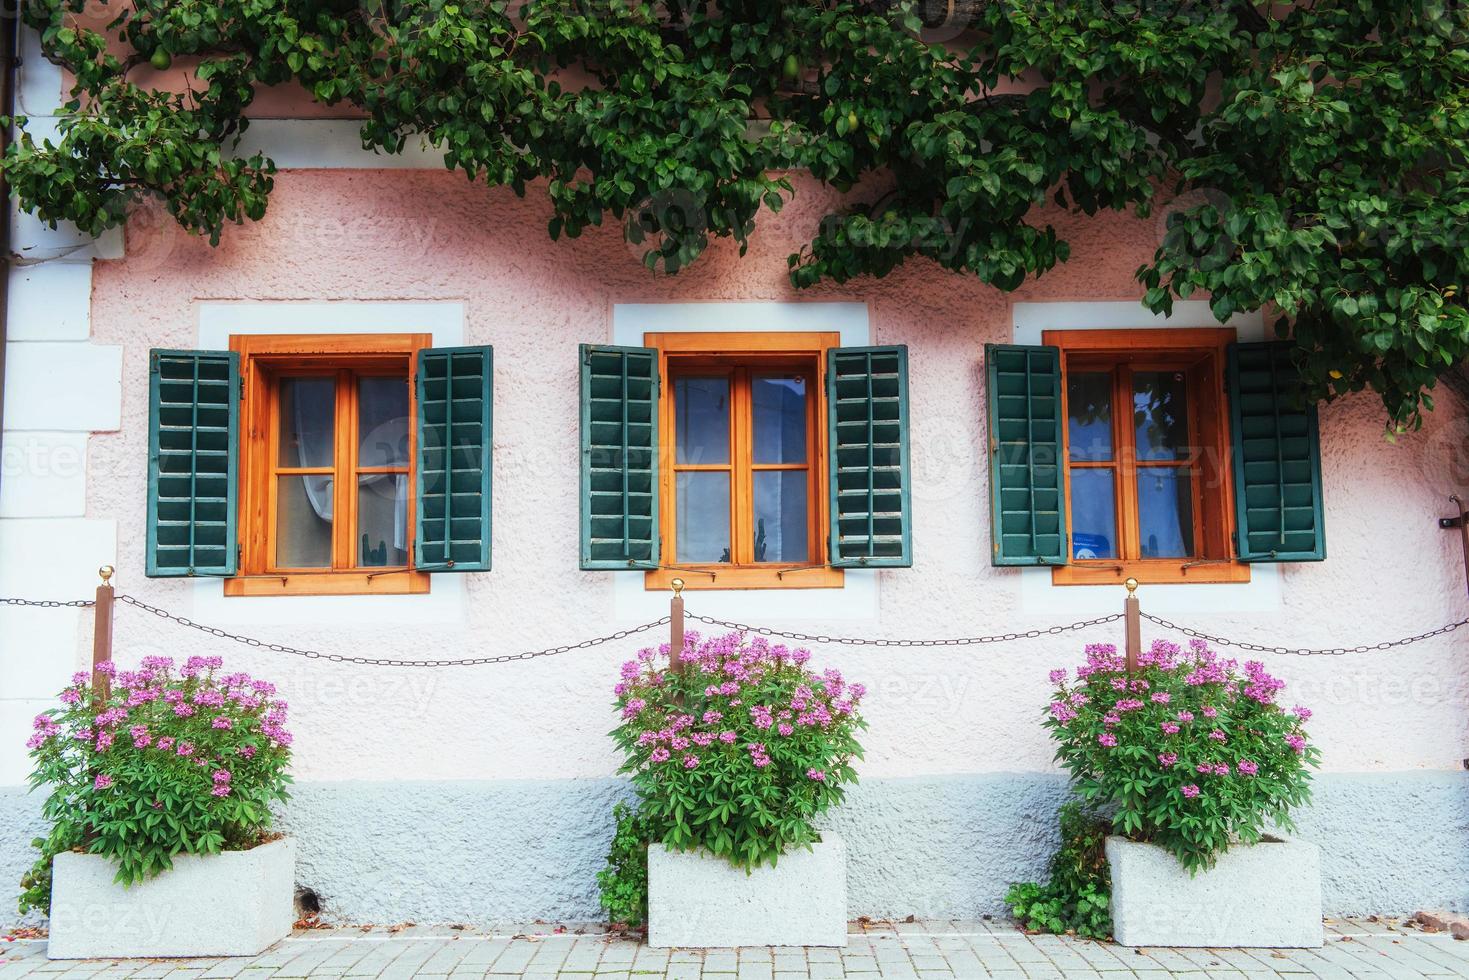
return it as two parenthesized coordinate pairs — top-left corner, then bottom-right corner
(0, 920), (1469, 980)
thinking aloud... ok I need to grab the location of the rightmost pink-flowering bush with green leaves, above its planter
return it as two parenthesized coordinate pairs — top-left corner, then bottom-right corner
(1046, 641), (1319, 871)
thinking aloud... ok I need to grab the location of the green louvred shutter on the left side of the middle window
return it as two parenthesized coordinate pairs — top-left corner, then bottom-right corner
(582, 344), (658, 570)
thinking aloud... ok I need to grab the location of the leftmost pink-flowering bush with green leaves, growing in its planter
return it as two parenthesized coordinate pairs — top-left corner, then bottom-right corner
(21, 657), (291, 912)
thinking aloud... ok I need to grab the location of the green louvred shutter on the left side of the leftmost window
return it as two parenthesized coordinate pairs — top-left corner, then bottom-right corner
(147, 350), (239, 577)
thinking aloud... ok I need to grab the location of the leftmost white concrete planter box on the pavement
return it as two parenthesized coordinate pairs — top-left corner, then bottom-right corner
(46, 837), (295, 959)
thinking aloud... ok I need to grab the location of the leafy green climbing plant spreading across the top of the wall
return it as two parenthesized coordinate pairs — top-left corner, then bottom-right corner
(4, 0), (1469, 426)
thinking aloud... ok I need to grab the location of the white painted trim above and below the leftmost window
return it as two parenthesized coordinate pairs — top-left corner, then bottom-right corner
(194, 300), (469, 626)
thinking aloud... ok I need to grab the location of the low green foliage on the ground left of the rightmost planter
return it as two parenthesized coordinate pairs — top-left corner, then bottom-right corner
(1005, 799), (1112, 939)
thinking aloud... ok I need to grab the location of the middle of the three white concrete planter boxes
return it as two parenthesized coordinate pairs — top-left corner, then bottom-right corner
(648, 833), (846, 949)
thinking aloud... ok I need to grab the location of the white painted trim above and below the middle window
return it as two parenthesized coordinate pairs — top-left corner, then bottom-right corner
(608, 303), (878, 623)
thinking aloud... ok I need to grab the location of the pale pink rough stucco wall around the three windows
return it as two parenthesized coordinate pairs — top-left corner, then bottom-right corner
(78, 170), (1469, 779)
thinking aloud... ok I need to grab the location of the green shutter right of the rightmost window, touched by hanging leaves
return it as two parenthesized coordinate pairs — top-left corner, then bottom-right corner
(1230, 342), (1327, 561)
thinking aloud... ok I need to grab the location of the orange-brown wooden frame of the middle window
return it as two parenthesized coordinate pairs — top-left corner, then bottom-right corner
(643, 332), (845, 591)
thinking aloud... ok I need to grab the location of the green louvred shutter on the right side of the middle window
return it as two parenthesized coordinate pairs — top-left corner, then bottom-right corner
(826, 345), (914, 569)
